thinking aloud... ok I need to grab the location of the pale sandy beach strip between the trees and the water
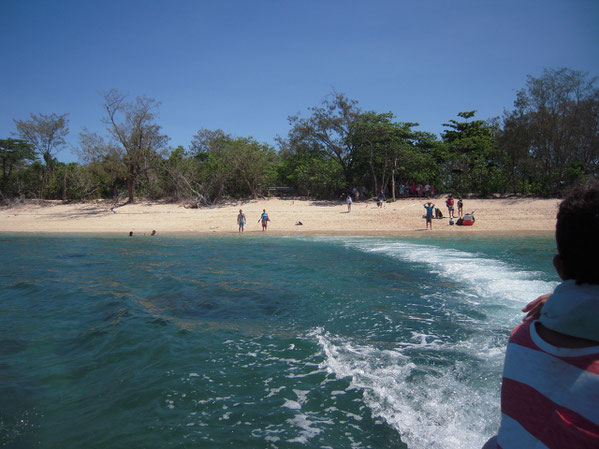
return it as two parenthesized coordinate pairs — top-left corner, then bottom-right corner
(0, 197), (559, 235)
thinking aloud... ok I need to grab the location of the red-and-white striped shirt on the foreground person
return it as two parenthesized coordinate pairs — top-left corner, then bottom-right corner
(497, 321), (599, 449)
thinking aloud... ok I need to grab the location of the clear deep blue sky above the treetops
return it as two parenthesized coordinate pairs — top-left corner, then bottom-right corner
(0, 0), (599, 162)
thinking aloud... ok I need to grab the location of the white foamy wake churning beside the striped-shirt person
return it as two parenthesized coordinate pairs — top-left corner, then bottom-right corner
(312, 329), (501, 449)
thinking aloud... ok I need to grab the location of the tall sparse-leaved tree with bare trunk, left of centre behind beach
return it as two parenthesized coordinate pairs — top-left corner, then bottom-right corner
(103, 89), (169, 203)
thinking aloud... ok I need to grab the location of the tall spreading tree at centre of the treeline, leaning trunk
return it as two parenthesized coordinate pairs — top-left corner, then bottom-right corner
(288, 92), (360, 184)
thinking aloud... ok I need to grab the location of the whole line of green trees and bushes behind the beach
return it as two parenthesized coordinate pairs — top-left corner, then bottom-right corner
(0, 68), (599, 205)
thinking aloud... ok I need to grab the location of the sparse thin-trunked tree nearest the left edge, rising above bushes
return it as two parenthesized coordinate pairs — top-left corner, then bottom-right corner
(14, 113), (69, 197)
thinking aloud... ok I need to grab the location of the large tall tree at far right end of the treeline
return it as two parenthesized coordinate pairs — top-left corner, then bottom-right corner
(502, 68), (599, 194)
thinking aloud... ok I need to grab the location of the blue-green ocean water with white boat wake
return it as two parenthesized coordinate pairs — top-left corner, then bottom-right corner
(0, 234), (558, 449)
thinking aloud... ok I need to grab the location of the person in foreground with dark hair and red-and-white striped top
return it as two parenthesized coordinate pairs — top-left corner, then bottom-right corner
(483, 181), (599, 449)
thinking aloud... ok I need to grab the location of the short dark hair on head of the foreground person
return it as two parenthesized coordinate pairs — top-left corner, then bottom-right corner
(555, 180), (599, 284)
